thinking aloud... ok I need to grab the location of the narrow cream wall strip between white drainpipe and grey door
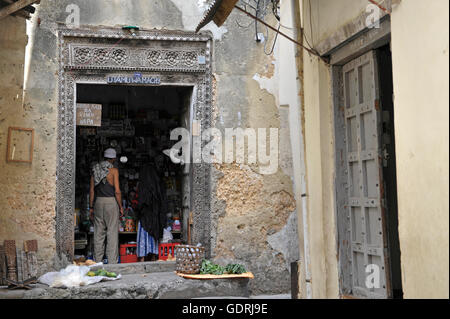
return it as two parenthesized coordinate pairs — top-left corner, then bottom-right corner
(301, 0), (354, 298)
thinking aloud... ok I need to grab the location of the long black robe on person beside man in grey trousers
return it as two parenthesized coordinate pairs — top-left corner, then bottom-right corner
(136, 164), (168, 240)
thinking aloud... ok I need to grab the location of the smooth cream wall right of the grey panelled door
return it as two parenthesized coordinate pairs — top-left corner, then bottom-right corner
(392, 0), (449, 298)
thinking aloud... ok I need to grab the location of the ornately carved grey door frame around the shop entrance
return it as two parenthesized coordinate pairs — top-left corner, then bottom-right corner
(55, 28), (212, 261)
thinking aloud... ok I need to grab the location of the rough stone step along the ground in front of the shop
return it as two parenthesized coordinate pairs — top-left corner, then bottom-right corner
(0, 272), (249, 299)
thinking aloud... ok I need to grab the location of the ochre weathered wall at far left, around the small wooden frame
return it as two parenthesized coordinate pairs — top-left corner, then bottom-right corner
(0, 17), (55, 274)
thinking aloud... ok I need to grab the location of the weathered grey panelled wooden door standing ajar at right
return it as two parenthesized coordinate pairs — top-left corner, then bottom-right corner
(343, 51), (391, 298)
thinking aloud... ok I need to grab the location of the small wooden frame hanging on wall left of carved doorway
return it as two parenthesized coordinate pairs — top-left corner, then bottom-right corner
(6, 127), (34, 163)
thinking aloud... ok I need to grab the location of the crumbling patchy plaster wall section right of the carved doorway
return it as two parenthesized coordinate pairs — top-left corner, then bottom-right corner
(212, 45), (298, 293)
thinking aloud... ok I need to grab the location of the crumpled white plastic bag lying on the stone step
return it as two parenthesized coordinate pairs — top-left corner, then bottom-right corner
(39, 263), (122, 288)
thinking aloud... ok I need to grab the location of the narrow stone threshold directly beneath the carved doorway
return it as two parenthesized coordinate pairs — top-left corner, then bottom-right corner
(91, 261), (176, 275)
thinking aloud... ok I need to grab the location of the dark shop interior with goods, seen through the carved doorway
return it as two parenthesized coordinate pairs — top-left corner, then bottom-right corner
(74, 84), (193, 263)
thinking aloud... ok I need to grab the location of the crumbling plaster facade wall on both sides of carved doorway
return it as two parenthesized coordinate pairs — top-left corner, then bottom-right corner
(2, 0), (298, 293)
